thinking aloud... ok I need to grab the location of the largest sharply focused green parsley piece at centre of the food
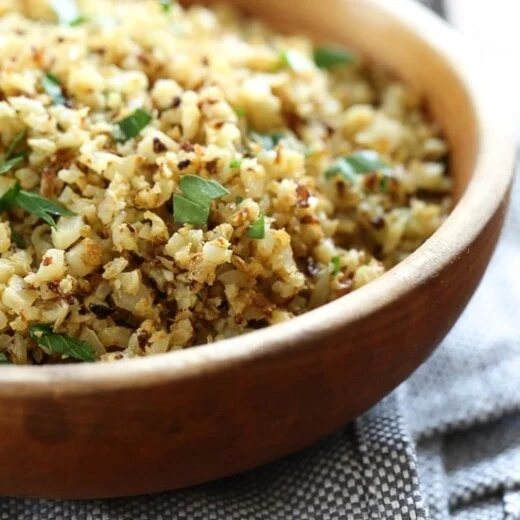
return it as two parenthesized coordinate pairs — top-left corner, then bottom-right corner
(173, 175), (229, 226)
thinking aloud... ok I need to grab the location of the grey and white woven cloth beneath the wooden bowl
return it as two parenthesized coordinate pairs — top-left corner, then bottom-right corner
(0, 0), (520, 520)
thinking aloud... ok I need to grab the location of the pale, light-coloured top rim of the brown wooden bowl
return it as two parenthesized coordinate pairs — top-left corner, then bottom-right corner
(0, 0), (516, 398)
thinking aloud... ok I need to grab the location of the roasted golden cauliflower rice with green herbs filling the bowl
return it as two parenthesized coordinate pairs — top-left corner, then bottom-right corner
(0, 0), (451, 364)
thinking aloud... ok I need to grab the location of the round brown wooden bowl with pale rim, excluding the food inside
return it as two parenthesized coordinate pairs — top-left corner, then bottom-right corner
(0, 0), (515, 498)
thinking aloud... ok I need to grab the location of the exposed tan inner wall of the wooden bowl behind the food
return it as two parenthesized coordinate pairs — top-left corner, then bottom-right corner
(182, 0), (478, 201)
